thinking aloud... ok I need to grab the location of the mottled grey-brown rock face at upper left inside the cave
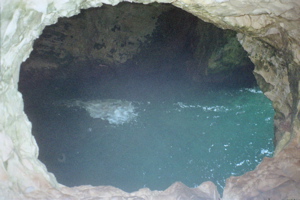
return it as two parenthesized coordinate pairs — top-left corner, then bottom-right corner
(25, 3), (170, 68)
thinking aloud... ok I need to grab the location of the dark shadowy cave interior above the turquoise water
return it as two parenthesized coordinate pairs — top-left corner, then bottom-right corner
(20, 3), (255, 89)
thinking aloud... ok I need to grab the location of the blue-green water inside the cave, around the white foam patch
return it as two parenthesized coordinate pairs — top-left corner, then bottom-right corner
(23, 76), (274, 192)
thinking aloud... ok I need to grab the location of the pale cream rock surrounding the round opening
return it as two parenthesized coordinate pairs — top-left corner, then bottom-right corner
(0, 0), (300, 200)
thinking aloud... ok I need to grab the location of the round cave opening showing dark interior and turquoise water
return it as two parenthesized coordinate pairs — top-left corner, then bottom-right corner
(19, 3), (274, 192)
